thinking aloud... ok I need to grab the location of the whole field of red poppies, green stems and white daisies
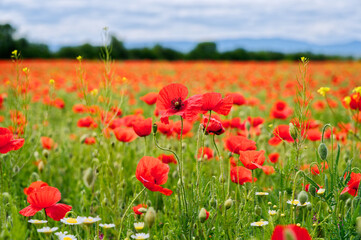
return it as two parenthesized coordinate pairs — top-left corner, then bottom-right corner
(0, 51), (361, 240)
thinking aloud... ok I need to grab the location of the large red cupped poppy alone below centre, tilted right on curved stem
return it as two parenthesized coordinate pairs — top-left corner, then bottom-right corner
(135, 156), (173, 196)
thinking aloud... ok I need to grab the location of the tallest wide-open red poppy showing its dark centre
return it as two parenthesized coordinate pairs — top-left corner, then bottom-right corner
(157, 83), (202, 123)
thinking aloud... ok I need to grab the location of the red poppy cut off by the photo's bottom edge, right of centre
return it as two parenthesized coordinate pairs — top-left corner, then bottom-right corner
(271, 224), (312, 240)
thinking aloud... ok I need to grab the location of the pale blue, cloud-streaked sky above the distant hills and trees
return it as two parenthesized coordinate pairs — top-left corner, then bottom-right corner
(0, 0), (361, 45)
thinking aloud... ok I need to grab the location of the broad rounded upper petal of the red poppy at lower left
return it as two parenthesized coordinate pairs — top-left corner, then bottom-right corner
(28, 186), (61, 208)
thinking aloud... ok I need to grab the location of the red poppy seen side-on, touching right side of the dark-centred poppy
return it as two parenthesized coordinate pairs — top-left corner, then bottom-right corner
(202, 93), (233, 116)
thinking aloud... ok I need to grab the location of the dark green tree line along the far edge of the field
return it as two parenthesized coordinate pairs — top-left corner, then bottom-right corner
(0, 24), (353, 61)
